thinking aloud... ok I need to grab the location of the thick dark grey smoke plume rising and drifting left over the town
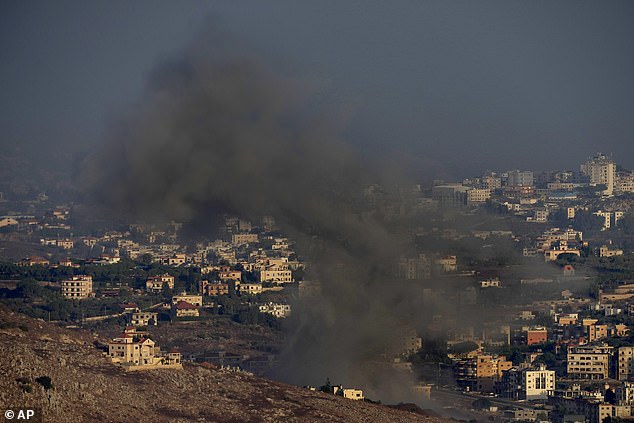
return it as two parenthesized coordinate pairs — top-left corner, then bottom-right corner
(80, 32), (424, 393)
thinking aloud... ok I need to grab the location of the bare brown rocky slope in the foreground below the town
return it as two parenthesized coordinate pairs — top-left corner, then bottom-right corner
(0, 306), (452, 423)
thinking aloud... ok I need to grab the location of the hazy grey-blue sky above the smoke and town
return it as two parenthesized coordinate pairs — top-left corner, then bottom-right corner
(0, 0), (634, 176)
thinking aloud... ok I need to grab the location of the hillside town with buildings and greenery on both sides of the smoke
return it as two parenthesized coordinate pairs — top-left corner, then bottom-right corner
(0, 154), (634, 423)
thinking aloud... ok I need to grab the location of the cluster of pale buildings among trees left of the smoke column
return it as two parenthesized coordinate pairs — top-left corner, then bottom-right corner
(10, 214), (304, 318)
